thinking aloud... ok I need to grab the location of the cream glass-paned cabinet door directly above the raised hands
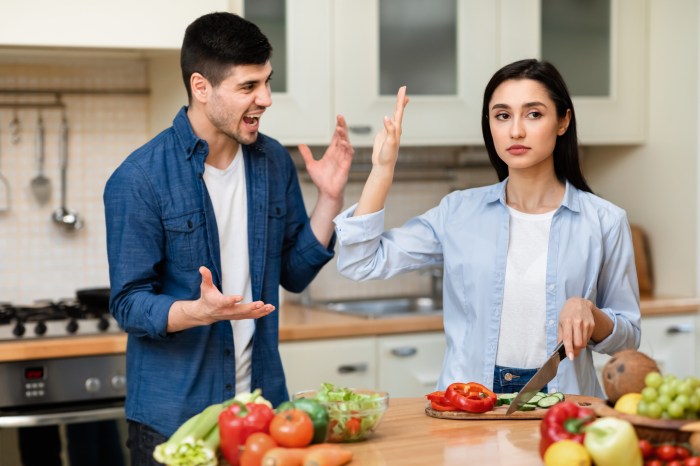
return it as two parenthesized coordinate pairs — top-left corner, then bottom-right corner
(333, 0), (497, 145)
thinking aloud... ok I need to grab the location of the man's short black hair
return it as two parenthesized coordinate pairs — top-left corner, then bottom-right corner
(180, 12), (272, 100)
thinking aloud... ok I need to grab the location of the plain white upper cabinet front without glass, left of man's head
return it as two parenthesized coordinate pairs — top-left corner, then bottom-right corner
(0, 0), (237, 49)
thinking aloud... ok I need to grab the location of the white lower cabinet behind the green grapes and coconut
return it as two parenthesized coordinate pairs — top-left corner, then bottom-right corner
(593, 314), (697, 388)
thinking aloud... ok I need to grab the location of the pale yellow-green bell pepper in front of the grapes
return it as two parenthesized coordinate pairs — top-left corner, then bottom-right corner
(583, 416), (643, 466)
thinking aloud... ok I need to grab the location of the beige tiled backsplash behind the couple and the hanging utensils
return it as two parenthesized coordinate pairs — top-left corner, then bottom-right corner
(0, 51), (495, 304)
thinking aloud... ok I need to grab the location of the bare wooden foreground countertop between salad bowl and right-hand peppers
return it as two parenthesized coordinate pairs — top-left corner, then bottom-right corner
(343, 398), (542, 466)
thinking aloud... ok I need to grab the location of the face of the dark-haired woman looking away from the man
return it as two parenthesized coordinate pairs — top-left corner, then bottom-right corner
(489, 79), (571, 175)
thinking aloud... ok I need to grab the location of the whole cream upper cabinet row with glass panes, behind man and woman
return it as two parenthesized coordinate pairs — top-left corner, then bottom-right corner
(243, 0), (648, 146)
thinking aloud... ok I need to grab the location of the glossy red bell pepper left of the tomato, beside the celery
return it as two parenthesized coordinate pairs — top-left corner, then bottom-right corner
(219, 402), (275, 466)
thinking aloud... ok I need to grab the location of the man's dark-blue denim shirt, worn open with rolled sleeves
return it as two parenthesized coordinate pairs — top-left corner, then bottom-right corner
(104, 108), (334, 436)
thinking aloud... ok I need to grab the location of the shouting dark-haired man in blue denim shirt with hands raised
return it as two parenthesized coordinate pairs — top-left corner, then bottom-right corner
(104, 13), (353, 465)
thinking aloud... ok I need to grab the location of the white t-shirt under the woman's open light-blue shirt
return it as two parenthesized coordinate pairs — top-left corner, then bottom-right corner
(496, 207), (555, 369)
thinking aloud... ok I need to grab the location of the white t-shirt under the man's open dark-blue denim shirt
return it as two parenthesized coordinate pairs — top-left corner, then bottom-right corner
(204, 147), (255, 393)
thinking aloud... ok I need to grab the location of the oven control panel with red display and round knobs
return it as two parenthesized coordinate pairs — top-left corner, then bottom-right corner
(0, 354), (126, 409)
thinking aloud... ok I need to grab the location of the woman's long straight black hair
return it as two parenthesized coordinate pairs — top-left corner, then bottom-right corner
(481, 59), (593, 192)
